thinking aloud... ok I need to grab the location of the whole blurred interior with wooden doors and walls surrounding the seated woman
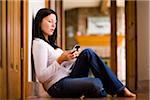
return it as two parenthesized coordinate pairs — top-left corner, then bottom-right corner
(0, 0), (150, 100)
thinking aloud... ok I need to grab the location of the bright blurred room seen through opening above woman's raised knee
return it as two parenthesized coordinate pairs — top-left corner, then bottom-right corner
(63, 0), (126, 84)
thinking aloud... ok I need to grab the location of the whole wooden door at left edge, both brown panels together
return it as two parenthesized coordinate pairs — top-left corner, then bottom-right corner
(0, 0), (21, 100)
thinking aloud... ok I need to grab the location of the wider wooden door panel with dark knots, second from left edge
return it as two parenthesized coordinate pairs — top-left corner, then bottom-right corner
(6, 0), (21, 99)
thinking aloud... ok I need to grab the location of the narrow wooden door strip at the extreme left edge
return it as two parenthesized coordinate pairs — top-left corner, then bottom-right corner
(0, 1), (7, 100)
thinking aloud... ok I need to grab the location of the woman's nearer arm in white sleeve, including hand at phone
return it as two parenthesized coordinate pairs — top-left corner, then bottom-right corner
(32, 42), (79, 83)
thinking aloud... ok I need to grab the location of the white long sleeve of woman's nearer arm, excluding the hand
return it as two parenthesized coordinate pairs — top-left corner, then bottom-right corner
(33, 42), (61, 83)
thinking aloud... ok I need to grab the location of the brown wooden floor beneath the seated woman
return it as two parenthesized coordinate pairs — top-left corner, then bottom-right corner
(27, 92), (150, 100)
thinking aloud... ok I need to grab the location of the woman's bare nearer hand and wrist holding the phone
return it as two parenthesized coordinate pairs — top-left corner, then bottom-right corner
(57, 51), (75, 64)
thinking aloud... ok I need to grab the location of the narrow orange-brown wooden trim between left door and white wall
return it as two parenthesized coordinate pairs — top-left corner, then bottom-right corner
(21, 0), (28, 99)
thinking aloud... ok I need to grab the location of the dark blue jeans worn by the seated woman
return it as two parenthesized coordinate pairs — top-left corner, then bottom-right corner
(48, 49), (125, 98)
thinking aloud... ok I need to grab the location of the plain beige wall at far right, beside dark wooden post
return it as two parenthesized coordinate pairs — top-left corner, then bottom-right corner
(137, 0), (150, 80)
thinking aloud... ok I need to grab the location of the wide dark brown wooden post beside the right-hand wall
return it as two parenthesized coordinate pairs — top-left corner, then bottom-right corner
(125, 1), (137, 90)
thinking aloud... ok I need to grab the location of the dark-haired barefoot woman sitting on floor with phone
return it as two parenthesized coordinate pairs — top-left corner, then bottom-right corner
(32, 8), (136, 98)
